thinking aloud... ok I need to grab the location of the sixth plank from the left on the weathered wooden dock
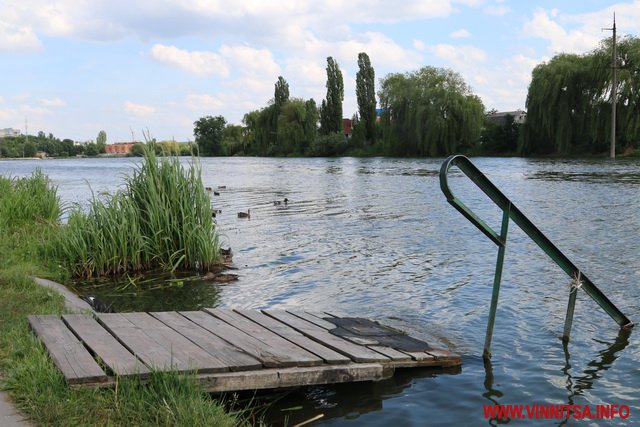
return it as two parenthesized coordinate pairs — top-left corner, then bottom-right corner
(180, 311), (296, 368)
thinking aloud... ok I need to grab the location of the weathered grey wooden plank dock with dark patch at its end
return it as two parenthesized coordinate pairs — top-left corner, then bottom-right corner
(28, 309), (460, 392)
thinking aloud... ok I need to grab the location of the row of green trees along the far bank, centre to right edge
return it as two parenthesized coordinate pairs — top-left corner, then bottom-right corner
(194, 36), (640, 156)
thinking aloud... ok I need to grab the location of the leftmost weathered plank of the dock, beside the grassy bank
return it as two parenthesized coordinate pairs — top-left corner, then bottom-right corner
(27, 316), (108, 384)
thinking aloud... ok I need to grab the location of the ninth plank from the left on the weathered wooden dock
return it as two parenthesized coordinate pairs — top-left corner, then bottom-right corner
(264, 310), (390, 363)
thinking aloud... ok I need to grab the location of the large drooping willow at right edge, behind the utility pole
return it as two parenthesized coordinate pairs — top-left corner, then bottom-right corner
(520, 37), (640, 154)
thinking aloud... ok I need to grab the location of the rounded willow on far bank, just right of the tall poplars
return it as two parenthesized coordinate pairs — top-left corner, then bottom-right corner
(378, 67), (484, 156)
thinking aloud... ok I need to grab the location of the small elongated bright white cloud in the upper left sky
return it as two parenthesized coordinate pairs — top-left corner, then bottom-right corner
(151, 44), (229, 77)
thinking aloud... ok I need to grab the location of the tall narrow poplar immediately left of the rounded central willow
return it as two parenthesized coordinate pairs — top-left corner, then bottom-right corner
(356, 52), (376, 144)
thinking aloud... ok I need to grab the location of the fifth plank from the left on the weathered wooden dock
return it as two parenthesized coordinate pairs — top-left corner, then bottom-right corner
(149, 311), (262, 371)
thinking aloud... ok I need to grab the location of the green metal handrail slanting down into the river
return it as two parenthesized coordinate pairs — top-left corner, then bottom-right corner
(440, 155), (633, 358)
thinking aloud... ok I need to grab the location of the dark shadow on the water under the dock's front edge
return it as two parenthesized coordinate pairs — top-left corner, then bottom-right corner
(229, 366), (462, 426)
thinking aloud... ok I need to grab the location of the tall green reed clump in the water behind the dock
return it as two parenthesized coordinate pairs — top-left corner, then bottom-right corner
(59, 148), (221, 278)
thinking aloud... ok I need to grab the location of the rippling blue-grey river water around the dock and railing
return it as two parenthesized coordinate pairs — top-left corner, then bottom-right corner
(0, 158), (640, 426)
